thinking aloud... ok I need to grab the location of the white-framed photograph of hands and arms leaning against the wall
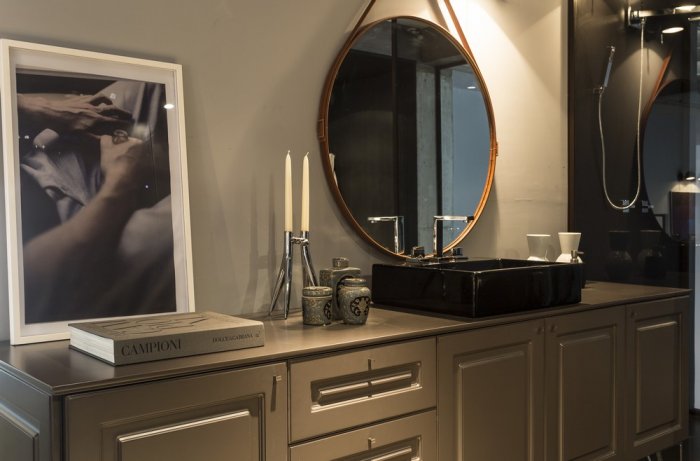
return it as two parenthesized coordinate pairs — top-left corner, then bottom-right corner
(0, 40), (194, 344)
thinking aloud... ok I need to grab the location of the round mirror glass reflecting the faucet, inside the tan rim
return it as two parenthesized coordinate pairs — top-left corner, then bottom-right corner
(320, 17), (496, 256)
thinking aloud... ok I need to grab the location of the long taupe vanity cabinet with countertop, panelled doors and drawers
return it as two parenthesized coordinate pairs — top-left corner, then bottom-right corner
(0, 282), (690, 461)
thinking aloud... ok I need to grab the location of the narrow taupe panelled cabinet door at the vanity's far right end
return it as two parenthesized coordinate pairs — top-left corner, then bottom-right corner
(627, 298), (689, 459)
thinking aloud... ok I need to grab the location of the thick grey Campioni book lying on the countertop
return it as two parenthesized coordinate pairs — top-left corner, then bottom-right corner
(68, 312), (265, 365)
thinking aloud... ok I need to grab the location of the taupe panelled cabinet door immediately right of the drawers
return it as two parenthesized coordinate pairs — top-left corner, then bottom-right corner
(438, 321), (544, 461)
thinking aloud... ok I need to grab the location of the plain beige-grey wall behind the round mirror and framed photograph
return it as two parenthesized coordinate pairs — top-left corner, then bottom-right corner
(0, 0), (566, 339)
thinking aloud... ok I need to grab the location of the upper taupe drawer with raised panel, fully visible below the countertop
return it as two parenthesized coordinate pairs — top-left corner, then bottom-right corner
(290, 338), (436, 441)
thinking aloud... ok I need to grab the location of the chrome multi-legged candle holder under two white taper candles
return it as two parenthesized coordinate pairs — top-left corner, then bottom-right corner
(269, 231), (318, 319)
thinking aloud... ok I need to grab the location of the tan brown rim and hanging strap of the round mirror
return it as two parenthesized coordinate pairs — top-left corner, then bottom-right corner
(318, 0), (498, 258)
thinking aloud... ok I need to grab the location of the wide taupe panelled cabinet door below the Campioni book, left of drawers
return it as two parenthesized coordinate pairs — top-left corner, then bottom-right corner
(66, 363), (287, 461)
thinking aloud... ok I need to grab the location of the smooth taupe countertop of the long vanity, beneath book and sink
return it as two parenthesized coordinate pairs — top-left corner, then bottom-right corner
(0, 282), (690, 396)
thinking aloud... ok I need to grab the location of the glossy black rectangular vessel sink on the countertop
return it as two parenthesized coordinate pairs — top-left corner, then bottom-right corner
(372, 259), (583, 317)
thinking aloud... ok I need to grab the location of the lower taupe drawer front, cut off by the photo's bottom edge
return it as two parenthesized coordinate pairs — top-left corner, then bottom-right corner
(290, 410), (437, 461)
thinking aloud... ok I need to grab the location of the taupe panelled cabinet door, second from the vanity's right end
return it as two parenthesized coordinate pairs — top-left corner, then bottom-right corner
(545, 307), (625, 461)
